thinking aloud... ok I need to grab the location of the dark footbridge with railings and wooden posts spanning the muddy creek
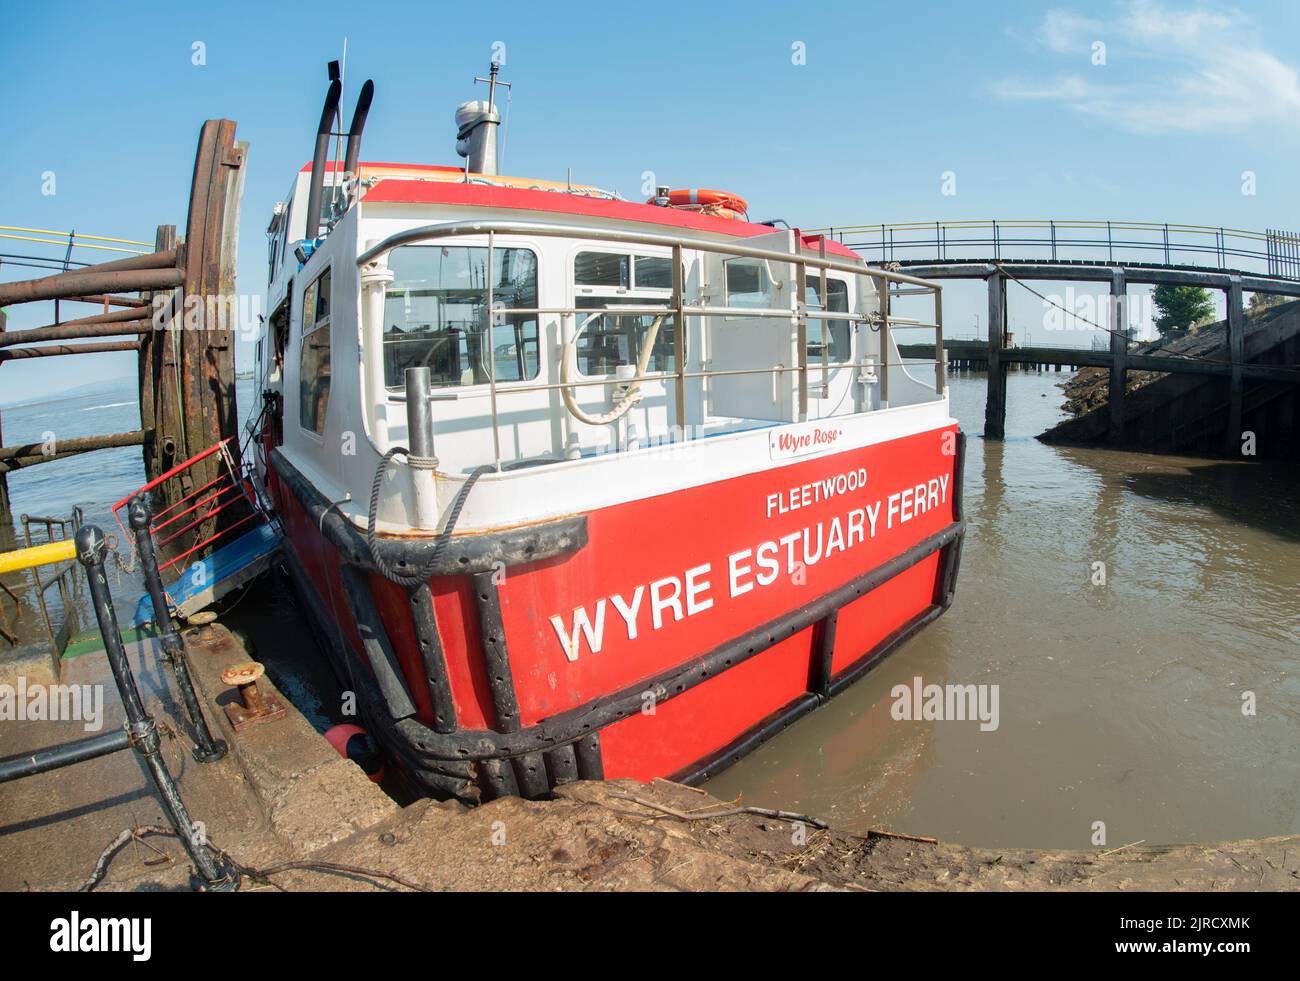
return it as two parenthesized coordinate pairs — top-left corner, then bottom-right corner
(816, 218), (1300, 452)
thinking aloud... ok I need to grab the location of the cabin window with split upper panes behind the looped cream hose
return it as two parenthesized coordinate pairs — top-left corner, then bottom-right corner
(573, 252), (677, 376)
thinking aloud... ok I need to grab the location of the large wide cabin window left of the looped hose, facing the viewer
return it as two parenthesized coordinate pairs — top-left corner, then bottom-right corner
(384, 246), (540, 389)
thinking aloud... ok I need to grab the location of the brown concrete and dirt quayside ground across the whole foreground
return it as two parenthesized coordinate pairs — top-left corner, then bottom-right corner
(0, 626), (1300, 891)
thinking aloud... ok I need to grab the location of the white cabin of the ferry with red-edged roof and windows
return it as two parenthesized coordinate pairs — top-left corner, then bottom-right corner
(253, 165), (946, 537)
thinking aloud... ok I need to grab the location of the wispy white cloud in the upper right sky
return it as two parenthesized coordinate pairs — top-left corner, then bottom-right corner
(992, 0), (1300, 134)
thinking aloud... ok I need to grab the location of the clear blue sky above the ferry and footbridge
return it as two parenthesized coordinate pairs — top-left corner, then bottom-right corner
(0, 0), (1300, 403)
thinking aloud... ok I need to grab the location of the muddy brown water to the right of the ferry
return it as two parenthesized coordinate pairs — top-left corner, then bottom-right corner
(707, 373), (1300, 848)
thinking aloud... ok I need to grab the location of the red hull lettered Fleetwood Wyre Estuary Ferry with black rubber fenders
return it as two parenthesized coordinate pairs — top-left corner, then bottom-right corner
(270, 427), (963, 795)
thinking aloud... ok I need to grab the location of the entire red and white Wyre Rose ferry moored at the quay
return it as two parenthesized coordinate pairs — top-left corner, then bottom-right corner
(256, 69), (965, 800)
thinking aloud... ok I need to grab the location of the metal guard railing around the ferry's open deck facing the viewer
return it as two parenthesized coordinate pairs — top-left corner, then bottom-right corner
(356, 221), (945, 469)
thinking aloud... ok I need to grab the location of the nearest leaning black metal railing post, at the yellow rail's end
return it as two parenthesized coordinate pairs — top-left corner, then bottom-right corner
(75, 525), (239, 893)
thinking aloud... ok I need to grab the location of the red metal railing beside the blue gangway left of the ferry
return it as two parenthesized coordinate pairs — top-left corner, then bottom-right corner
(112, 438), (267, 572)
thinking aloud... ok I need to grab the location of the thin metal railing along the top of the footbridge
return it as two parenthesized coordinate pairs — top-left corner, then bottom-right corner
(813, 218), (1300, 279)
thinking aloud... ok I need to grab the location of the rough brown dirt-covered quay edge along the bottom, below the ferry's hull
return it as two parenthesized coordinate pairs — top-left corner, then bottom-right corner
(45, 781), (1300, 891)
